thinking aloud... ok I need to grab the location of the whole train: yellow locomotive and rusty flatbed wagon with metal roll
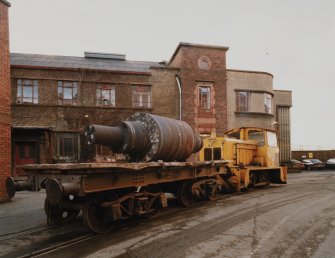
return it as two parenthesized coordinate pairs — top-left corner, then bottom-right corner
(6, 113), (287, 233)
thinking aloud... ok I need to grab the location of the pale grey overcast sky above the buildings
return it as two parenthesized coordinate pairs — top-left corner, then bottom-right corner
(9, 0), (335, 149)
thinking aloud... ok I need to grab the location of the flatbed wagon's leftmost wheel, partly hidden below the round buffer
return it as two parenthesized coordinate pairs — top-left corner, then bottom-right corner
(44, 199), (80, 225)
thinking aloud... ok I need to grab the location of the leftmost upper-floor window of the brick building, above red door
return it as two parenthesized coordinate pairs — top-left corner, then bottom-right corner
(17, 79), (38, 104)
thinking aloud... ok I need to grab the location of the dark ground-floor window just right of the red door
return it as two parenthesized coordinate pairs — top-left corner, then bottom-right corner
(54, 132), (79, 162)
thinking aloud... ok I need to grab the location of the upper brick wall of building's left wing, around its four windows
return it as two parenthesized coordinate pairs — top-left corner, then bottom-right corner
(11, 66), (152, 130)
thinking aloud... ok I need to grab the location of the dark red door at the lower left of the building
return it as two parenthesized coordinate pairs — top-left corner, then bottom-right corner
(14, 142), (37, 176)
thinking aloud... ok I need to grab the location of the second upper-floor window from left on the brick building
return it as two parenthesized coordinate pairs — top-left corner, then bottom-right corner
(58, 81), (78, 105)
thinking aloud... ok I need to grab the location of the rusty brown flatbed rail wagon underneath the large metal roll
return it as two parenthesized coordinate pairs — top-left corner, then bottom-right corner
(6, 161), (230, 233)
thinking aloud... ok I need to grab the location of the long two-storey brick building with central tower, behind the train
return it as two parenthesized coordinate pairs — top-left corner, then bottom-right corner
(11, 43), (291, 175)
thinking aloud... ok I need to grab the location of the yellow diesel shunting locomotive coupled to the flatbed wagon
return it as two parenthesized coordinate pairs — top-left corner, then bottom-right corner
(199, 127), (287, 189)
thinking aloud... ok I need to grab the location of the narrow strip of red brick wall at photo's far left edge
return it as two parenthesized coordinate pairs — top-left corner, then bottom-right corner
(0, 1), (11, 201)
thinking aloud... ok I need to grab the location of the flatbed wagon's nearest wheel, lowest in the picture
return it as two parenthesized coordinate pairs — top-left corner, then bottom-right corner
(83, 192), (117, 233)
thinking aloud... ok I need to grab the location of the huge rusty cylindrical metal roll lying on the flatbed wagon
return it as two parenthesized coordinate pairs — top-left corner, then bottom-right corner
(85, 113), (202, 161)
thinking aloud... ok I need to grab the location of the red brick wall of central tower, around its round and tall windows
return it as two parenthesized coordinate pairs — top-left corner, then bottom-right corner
(171, 44), (227, 134)
